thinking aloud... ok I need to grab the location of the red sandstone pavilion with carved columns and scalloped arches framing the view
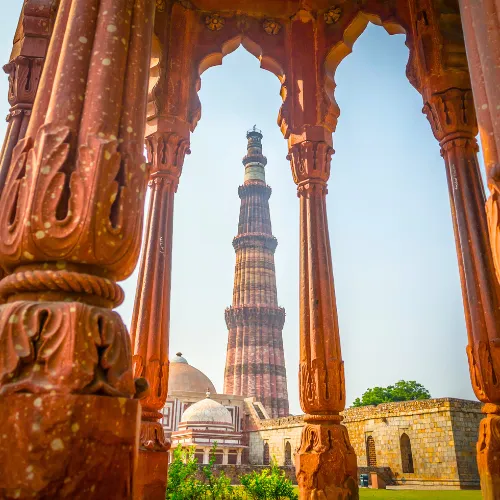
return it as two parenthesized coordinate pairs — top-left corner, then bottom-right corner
(0, 0), (500, 500)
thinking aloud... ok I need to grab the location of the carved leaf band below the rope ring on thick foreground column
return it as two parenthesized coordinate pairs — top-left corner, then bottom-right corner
(0, 302), (135, 397)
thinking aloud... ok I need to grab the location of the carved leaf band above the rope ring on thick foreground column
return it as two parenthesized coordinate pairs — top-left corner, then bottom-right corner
(0, 124), (146, 277)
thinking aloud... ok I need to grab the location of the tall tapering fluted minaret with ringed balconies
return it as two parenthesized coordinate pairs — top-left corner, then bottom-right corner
(224, 127), (288, 418)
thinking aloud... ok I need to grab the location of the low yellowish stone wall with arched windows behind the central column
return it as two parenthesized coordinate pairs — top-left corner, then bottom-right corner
(248, 398), (482, 488)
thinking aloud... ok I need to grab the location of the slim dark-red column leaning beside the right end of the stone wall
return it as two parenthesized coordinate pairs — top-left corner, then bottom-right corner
(424, 88), (500, 500)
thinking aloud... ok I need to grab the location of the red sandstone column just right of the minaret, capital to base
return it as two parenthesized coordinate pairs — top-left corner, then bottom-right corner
(289, 130), (359, 499)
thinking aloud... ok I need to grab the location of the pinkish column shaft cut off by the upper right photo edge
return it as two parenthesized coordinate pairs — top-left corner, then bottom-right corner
(459, 0), (500, 290)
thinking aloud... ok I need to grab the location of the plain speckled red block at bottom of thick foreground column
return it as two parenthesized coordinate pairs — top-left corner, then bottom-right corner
(0, 394), (141, 500)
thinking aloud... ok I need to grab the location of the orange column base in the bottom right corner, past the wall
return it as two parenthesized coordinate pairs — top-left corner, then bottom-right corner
(477, 404), (500, 500)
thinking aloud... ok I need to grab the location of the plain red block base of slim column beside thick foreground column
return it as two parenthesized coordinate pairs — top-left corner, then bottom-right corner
(135, 449), (169, 500)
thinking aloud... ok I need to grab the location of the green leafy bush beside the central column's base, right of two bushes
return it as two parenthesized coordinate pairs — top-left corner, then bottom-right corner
(240, 460), (299, 500)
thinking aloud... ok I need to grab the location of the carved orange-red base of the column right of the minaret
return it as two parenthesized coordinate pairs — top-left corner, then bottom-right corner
(295, 419), (359, 500)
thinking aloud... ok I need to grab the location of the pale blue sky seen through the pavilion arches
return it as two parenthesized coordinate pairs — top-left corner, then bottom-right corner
(0, 0), (474, 413)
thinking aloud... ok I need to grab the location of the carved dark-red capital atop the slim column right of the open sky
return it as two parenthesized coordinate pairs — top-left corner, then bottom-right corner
(422, 88), (478, 146)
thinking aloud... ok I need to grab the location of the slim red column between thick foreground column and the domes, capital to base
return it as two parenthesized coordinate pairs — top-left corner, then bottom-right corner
(131, 132), (189, 500)
